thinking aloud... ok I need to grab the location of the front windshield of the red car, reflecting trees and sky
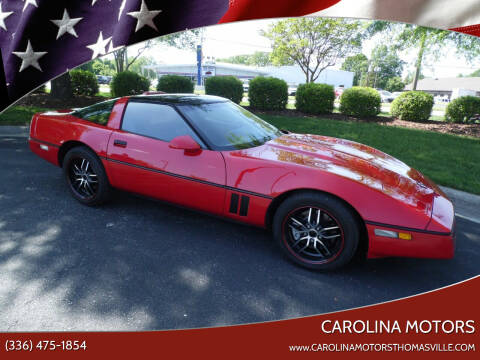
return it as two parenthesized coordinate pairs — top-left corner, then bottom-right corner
(178, 101), (282, 150)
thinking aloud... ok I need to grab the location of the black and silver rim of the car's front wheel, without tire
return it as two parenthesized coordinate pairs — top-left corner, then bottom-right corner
(282, 206), (344, 264)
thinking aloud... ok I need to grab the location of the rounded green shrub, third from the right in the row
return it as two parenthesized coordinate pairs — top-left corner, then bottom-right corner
(340, 86), (382, 117)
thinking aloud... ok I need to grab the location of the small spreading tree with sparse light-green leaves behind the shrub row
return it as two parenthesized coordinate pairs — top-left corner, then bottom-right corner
(262, 17), (363, 83)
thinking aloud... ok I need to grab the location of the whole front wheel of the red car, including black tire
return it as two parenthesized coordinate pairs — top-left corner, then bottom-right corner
(272, 192), (361, 270)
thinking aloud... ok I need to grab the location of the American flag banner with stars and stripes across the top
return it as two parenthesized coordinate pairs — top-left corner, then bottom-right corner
(0, 0), (480, 111)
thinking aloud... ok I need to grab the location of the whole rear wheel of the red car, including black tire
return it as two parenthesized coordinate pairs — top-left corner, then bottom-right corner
(63, 146), (111, 206)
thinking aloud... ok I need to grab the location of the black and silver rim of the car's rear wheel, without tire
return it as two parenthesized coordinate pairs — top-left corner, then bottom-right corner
(68, 157), (98, 199)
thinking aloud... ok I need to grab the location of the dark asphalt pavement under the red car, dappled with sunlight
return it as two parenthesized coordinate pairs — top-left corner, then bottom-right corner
(0, 135), (480, 331)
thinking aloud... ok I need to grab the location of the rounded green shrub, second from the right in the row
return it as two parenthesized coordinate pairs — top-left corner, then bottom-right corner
(391, 91), (433, 121)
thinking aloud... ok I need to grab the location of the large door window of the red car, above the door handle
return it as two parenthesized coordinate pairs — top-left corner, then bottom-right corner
(122, 101), (205, 147)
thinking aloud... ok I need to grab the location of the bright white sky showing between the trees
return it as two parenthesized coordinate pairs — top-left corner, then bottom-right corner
(124, 20), (480, 78)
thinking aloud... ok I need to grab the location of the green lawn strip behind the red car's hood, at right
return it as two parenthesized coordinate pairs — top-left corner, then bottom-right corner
(260, 114), (480, 194)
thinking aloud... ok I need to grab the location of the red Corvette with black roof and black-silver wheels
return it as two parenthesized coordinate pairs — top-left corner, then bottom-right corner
(29, 95), (455, 269)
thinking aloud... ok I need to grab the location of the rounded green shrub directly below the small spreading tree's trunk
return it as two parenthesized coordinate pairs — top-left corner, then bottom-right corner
(295, 83), (335, 114)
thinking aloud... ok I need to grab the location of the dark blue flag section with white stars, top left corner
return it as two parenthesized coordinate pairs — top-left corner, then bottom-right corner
(0, 0), (228, 110)
